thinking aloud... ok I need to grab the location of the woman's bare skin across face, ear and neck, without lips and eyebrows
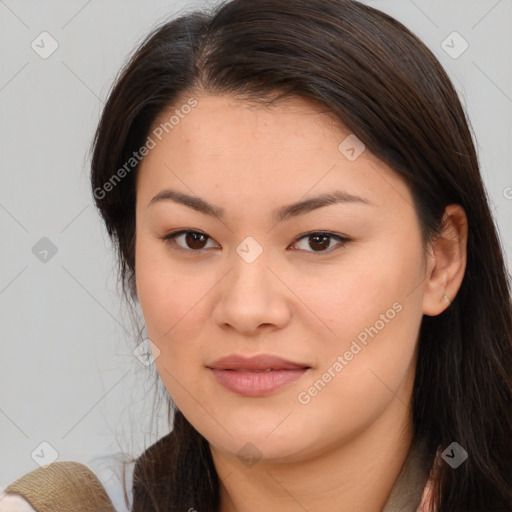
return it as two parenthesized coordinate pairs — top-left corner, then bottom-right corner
(135, 91), (467, 512)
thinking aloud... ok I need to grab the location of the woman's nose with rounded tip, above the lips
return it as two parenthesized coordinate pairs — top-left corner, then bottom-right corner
(213, 255), (293, 336)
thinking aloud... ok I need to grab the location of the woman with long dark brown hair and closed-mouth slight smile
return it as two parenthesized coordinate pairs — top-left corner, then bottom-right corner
(2, 0), (512, 512)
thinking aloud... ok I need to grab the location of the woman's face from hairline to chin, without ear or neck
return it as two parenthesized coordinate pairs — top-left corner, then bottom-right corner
(135, 95), (427, 461)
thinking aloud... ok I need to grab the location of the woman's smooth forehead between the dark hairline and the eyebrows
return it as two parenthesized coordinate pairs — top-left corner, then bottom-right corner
(137, 94), (412, 216)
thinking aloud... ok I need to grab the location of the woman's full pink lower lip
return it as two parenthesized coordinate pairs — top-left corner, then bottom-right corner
(210, 368), (309, 396)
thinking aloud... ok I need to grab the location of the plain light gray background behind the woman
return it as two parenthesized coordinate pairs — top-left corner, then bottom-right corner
(0, 0), (512, 498)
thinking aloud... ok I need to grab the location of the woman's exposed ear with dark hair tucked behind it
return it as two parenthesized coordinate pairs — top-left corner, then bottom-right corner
(423, 204), (468, 316)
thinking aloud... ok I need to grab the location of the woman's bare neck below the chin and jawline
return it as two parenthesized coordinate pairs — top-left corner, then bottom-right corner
(210, 398), (412, 512)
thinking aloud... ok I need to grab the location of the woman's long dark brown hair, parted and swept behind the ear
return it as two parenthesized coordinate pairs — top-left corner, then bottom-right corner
(91, 0), (512, 512)
